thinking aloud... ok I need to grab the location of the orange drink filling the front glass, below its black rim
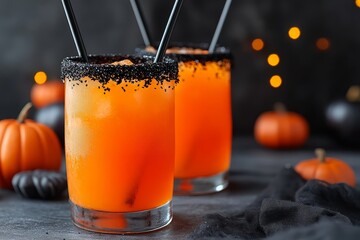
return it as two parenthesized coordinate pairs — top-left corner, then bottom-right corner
(65, 78), (175, 212)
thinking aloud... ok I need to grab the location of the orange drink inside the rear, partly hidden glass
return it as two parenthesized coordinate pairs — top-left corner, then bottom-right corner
(175, 60), (232, 178)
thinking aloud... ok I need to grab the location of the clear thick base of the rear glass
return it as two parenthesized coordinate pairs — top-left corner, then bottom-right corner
(174, 172), (229, 195)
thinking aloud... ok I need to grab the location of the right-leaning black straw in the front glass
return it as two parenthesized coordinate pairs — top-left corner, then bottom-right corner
(154, 0), (183, 63)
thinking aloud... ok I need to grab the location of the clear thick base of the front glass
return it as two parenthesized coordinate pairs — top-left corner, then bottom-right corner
(70, 201), (172, 234)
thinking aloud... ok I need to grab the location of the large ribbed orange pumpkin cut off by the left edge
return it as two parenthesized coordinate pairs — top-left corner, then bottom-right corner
(0, 103), (62, 188)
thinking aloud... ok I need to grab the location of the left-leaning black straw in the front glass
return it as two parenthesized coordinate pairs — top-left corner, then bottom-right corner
(61, 0), (89, 62)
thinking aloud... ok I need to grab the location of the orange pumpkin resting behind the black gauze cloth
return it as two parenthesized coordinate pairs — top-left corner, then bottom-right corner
(295, 148), (356, 187)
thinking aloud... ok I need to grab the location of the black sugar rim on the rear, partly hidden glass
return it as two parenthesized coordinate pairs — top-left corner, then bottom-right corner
(136, 42), (233, 64)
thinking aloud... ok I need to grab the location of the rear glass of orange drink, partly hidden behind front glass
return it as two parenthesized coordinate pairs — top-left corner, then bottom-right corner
(139, 44), (232, 195)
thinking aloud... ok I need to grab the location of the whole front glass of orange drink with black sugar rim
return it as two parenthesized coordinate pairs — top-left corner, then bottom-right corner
(62, 55), (178, 233)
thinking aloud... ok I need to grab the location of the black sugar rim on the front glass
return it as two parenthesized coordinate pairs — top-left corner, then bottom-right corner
(61, 54), (178, 85)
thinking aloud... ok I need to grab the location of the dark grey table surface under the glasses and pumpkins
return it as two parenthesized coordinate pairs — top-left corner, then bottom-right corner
(0, 137), (360, 240)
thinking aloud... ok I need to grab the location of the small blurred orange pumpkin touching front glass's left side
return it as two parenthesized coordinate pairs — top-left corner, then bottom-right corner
(31, 80), (65, 108)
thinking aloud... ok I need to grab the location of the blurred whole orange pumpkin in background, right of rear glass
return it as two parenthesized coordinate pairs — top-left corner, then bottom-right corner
(254, 103), (309, 148)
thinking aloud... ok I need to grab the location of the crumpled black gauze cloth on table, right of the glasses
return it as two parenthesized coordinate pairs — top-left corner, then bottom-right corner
(189, 168), (360, 239)
